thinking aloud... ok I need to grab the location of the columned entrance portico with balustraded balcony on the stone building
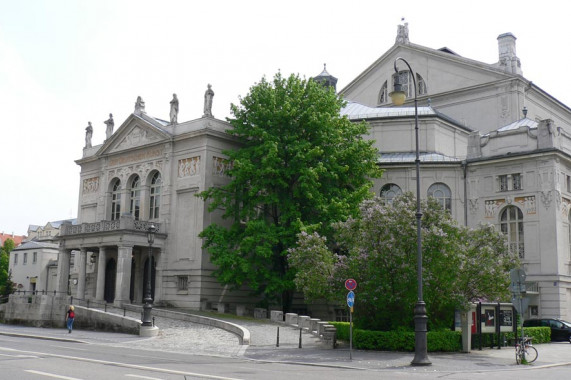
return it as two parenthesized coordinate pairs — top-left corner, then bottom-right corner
(57, 216), (166, 306)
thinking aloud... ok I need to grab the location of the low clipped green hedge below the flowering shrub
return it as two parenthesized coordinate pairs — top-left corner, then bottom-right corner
(330, 322), (462, 352)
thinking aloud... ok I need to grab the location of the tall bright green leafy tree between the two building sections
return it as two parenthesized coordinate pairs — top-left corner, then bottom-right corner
(200, 73), (380, 310)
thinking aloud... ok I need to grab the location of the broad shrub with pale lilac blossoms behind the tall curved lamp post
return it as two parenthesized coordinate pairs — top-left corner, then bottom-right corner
(290, 193), (518, 330)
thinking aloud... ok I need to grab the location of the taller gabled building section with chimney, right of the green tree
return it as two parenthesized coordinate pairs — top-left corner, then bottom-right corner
(340, 25), (571, 319)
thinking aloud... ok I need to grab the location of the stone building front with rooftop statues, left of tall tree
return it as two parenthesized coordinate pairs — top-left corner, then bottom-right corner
(58, 88), (239, 309)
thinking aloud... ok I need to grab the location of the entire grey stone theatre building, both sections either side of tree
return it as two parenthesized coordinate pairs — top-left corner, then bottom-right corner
(58, 25), (571, 319)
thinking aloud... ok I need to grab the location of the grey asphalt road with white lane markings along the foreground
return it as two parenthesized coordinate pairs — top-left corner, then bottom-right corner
(0, 336), (571, 380)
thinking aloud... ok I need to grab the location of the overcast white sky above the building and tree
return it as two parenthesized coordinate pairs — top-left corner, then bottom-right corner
(0, 0), (571, 235)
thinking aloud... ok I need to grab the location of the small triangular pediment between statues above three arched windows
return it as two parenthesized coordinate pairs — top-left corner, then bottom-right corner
(98, 114), (171, 155)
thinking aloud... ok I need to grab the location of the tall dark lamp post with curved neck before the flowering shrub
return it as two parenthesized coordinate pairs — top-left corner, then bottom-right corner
(390, 57), (432, 366)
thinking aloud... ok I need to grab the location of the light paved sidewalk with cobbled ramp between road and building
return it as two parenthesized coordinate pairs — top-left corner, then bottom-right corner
(0, 316), (571, 372)
